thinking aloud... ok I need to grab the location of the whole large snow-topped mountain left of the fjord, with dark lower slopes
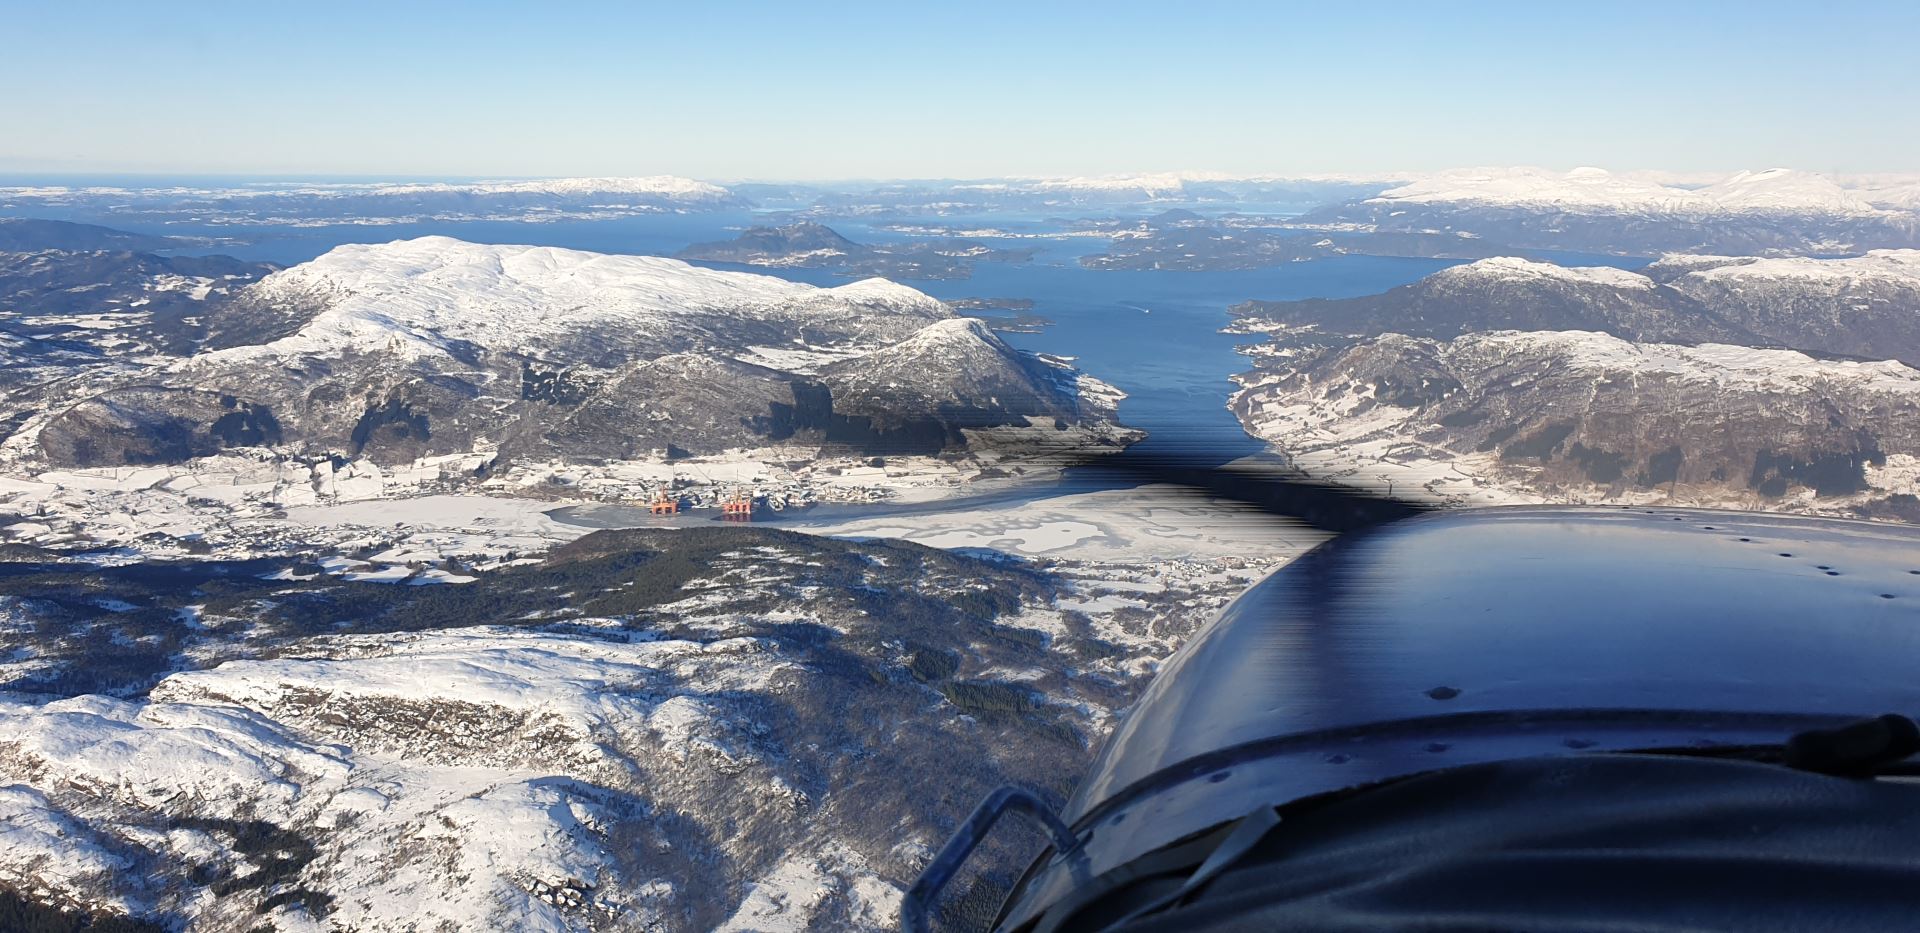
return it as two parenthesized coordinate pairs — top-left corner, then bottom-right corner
(6, 238), (1110, 465)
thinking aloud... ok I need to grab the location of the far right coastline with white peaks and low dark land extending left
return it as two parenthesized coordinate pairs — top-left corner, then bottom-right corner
(1081, 167), (1920, 271)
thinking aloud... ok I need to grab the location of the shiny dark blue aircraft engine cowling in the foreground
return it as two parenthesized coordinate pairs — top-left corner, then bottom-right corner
(1008, 509), (1920, 921)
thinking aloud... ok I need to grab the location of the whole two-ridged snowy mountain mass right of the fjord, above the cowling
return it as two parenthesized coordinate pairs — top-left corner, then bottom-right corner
(1233, 250), (1920, 513)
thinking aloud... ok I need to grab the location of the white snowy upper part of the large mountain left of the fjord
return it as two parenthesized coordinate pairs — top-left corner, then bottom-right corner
(196, 236), (952, 363)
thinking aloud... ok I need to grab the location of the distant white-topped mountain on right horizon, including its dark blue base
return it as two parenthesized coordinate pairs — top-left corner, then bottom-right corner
(1300, 167), (1920, 255)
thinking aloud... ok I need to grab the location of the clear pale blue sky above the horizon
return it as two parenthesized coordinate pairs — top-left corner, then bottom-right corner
(0, 0), (1920, 179)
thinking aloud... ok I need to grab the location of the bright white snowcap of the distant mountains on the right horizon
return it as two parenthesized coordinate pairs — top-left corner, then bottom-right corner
(1373, 165), (1880, 215)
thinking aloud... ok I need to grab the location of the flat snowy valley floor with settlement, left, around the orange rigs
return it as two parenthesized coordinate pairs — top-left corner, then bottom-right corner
(0, 439), (1121, 580)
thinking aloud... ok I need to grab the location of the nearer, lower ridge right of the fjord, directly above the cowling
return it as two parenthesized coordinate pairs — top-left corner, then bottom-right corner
(1233, 330), (1920, 511)
